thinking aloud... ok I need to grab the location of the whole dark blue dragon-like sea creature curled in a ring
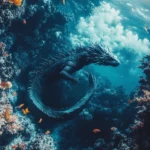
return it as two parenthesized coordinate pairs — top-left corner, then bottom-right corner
(29, 44), (120, 118)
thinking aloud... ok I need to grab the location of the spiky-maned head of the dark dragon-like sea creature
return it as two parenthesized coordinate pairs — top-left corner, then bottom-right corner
(88, 44), (120, 67)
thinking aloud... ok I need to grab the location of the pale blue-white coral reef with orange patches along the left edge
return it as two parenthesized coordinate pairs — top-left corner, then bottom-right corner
(0, 42), (56, 150)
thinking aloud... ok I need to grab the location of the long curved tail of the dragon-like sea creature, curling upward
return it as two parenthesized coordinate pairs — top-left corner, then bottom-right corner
(29, 72), (97, 118)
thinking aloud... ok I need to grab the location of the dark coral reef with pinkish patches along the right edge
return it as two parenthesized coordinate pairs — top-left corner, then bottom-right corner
(107, 55), (150, 150)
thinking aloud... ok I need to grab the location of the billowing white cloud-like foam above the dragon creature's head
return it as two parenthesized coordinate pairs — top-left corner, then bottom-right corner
(70, 2), (150, 54)
